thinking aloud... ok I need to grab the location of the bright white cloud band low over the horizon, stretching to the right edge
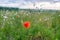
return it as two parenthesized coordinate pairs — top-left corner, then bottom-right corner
(19, 2), (60, 10)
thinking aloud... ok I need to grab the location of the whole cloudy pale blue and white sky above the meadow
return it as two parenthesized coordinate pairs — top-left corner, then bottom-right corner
(0, 0), (60, 9)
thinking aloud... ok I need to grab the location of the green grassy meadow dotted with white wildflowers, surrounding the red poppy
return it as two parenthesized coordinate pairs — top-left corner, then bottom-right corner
(0, 10), (60, 40)
